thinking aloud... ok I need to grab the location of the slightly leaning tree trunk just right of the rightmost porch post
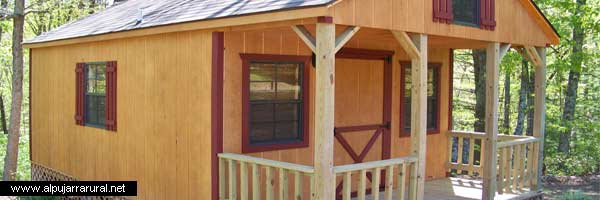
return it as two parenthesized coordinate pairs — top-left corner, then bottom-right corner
(558, 0), (586, 153)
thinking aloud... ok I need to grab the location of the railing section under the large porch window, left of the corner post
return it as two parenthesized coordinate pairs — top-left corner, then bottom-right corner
(219, 153), (314, 200)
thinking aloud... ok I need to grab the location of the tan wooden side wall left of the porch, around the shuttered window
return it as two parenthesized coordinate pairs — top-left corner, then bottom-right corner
(32, 31), (212, 199)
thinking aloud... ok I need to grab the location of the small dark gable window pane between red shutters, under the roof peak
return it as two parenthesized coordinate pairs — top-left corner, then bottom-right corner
(452, 0), (479, 26)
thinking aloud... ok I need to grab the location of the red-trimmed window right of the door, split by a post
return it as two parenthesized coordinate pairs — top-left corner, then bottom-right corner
(400, 62), (441, 136)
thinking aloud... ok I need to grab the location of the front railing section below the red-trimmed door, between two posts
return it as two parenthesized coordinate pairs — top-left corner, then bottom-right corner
(334, 157), (417, 200)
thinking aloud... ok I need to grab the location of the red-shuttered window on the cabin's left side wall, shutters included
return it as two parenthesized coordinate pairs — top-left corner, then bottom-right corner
(75, 61), (117, 131)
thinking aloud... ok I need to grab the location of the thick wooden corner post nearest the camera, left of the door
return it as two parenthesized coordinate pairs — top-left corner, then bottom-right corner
(313, 17), (335, 200)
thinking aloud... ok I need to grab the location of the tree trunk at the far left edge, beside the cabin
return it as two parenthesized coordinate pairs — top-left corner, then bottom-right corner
(3, 0), (25, 181)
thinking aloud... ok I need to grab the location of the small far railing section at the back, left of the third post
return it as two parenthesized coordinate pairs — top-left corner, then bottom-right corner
(446, 131), (485, 176)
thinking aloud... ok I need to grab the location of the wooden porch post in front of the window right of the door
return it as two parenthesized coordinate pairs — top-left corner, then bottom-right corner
(409, 34), (428, 200)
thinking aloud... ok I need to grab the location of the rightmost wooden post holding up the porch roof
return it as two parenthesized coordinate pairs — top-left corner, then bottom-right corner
(532, 48), (546, 191)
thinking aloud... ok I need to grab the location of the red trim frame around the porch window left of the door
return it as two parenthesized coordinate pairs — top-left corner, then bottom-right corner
(240, 54), (311, 153)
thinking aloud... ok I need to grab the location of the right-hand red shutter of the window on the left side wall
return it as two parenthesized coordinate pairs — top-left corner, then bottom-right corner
(105, 61), (117, 131)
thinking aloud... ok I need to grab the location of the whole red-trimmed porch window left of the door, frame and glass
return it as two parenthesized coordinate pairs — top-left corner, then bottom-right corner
(242, 54), (310, 153)
